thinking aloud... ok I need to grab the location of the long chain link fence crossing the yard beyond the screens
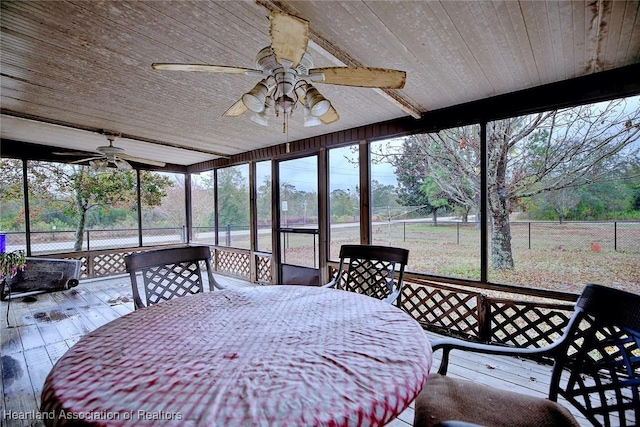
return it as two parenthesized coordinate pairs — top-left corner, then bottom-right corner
(2, 220), (640, 256)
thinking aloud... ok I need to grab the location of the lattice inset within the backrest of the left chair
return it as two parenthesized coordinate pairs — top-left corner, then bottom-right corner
(142, 262), (202, 305)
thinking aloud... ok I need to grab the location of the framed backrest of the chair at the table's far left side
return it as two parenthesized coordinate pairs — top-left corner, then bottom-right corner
(124, 246), (217, 309)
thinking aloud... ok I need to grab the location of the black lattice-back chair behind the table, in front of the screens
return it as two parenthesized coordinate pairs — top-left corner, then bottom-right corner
(324, 245), (409, 304)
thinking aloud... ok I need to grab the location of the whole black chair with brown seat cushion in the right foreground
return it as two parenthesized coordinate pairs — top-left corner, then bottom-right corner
(414, 284), (640, 427)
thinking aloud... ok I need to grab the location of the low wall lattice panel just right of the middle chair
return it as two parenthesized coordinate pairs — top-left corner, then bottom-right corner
(401, 280), (480, 337)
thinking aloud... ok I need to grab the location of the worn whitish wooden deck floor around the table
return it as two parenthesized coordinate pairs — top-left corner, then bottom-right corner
(0, 276), (590, 427)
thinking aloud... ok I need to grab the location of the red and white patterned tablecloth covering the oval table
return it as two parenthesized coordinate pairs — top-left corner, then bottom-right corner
(41, 286), (431, 427)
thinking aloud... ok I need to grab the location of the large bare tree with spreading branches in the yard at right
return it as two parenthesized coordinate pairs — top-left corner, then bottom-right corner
(387, 98), (640, 269)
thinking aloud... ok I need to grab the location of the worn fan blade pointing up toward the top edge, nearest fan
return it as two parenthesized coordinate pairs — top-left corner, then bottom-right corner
(269, 11), (309, 68)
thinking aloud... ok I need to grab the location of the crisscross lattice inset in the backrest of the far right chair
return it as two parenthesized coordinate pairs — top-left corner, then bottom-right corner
(560, 317), (640, 426)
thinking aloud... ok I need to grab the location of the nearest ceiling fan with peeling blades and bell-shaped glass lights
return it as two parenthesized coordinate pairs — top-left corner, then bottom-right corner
(151, 11), (406, 132)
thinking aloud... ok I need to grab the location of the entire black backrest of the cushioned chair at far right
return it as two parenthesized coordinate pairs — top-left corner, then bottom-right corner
(549, 284), (640, 426)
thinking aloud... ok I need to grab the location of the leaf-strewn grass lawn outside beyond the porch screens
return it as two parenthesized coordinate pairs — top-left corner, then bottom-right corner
(202, 222), (640, 293)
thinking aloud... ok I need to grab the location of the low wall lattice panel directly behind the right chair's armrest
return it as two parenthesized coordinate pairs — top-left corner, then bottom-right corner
(489, 300), (573, 347)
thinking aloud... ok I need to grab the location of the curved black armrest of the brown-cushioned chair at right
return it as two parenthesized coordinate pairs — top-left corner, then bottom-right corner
(431, 338), (560, 375)
